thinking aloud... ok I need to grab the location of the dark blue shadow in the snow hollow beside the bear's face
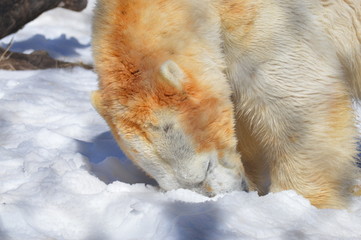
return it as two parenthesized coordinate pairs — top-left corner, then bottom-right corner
(77, 131), (158, 186)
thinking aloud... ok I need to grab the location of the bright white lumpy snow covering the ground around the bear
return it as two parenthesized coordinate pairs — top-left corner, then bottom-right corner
(0, 1), (361, 240)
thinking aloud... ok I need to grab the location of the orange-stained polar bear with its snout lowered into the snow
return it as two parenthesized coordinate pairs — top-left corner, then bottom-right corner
(92, 0), (361, 208)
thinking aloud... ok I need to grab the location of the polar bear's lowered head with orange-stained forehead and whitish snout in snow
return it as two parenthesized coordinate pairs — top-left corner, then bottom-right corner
(92, 60), (247, 196)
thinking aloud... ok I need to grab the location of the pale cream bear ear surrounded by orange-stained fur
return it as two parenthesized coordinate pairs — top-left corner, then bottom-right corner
(160, 60), (185, 90)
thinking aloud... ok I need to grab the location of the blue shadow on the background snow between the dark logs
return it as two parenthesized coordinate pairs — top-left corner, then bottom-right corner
(0, 34), (90, 58)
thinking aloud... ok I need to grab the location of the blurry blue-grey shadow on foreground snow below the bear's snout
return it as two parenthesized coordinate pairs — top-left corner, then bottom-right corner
(164, 201), (239, 240)
